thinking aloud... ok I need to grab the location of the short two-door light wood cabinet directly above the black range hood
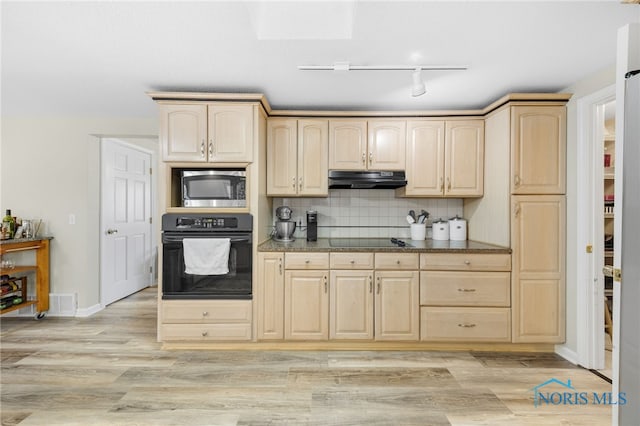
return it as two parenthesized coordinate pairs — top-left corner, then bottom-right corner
(329, 118), (406, 170)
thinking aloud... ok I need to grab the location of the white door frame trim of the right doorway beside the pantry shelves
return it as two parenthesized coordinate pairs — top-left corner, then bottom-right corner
(576, 84), (616, 369)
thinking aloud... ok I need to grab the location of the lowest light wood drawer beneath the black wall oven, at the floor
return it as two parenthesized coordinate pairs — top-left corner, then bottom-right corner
(160, 324), (251, 342)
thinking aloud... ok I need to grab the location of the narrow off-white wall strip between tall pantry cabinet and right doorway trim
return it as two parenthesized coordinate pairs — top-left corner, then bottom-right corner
(562, 65), (616, 353)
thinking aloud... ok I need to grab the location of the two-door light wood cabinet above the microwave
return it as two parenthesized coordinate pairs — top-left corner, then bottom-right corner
(160, 102), (254, 163)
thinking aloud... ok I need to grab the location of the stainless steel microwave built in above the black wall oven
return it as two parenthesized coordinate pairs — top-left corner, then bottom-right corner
(180, 169), (247, 207)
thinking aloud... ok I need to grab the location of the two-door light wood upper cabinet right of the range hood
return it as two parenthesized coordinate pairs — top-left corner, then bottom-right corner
(397, 120), (484, 197)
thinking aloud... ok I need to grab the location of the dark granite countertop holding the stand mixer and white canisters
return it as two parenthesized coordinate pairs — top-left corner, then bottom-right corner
(258, 238), (511, 254)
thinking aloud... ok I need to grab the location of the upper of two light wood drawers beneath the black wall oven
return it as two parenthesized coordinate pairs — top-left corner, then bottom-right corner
(161, 300), (251, 324)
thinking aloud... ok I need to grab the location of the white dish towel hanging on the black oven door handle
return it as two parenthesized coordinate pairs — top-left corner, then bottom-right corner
(182, 238), (231, 275)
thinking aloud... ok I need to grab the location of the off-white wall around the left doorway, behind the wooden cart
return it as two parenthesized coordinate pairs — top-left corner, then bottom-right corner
(0, 117), (158, 310)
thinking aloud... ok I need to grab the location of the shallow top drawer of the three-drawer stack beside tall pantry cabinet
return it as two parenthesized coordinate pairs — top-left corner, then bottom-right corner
(420, 253), (511, 271)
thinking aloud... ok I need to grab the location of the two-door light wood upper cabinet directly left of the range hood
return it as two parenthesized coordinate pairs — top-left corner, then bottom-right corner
(267, 118), (329, 196)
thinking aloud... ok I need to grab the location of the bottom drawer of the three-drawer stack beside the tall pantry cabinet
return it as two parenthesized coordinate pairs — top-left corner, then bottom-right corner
(420, 307), (511, 342)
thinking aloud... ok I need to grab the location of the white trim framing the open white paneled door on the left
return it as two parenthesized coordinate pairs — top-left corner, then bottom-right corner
(96, 135), (158, 310)
